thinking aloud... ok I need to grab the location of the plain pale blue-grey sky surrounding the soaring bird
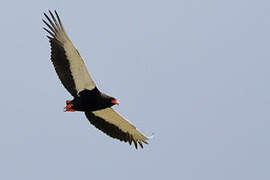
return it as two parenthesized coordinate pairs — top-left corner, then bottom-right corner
(0, 0), (270, 180)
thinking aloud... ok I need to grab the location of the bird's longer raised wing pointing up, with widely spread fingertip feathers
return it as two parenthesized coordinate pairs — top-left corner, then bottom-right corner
(42, 11), (96, 97)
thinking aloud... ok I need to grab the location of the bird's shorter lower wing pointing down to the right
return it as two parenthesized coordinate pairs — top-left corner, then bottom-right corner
(85, 108), (148, 149)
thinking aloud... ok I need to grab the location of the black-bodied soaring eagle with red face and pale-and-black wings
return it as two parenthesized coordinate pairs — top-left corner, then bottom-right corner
(42, 10), (149, 149)
